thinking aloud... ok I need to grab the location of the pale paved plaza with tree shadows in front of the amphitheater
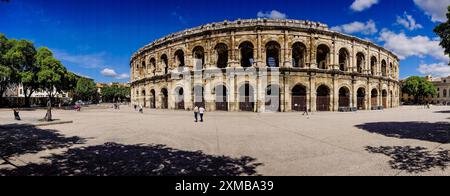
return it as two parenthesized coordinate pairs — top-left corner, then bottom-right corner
(0, 106), (450, 176)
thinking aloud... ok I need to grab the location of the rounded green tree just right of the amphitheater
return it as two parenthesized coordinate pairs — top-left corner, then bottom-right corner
(402, 76), (437, 104)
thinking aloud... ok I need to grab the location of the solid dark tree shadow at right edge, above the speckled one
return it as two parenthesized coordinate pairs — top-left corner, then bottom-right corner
(356, 122), (450, 144)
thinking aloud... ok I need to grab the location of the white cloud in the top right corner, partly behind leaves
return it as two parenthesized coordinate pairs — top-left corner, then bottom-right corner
(414, 0), (450, 22)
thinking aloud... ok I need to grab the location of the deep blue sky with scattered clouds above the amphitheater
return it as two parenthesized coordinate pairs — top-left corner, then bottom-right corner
(0, 0), (450, 82)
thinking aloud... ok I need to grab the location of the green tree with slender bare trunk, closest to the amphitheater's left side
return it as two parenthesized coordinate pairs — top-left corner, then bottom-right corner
(37, 48), (67, 121)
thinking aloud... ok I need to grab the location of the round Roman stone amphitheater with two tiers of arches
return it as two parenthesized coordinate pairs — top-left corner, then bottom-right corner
(130, 19), (400, 112)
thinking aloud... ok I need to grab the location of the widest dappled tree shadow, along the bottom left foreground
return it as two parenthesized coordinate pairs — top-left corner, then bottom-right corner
(0, 143), (262, 176)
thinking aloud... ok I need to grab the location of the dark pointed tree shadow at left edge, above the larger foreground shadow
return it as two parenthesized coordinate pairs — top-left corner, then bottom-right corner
(0, 124), (85, 159)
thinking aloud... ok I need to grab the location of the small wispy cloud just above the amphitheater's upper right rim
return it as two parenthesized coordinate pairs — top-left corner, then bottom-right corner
(331, 20), (378, 35)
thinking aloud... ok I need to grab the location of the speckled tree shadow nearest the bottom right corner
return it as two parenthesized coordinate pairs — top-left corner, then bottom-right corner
(366, 146), (450, 173)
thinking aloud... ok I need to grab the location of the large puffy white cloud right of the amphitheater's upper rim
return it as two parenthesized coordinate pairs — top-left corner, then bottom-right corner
(378, 29), (450, 62)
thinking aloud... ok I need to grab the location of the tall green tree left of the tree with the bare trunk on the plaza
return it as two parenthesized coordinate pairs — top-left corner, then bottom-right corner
(5, 40), (39, 107)
